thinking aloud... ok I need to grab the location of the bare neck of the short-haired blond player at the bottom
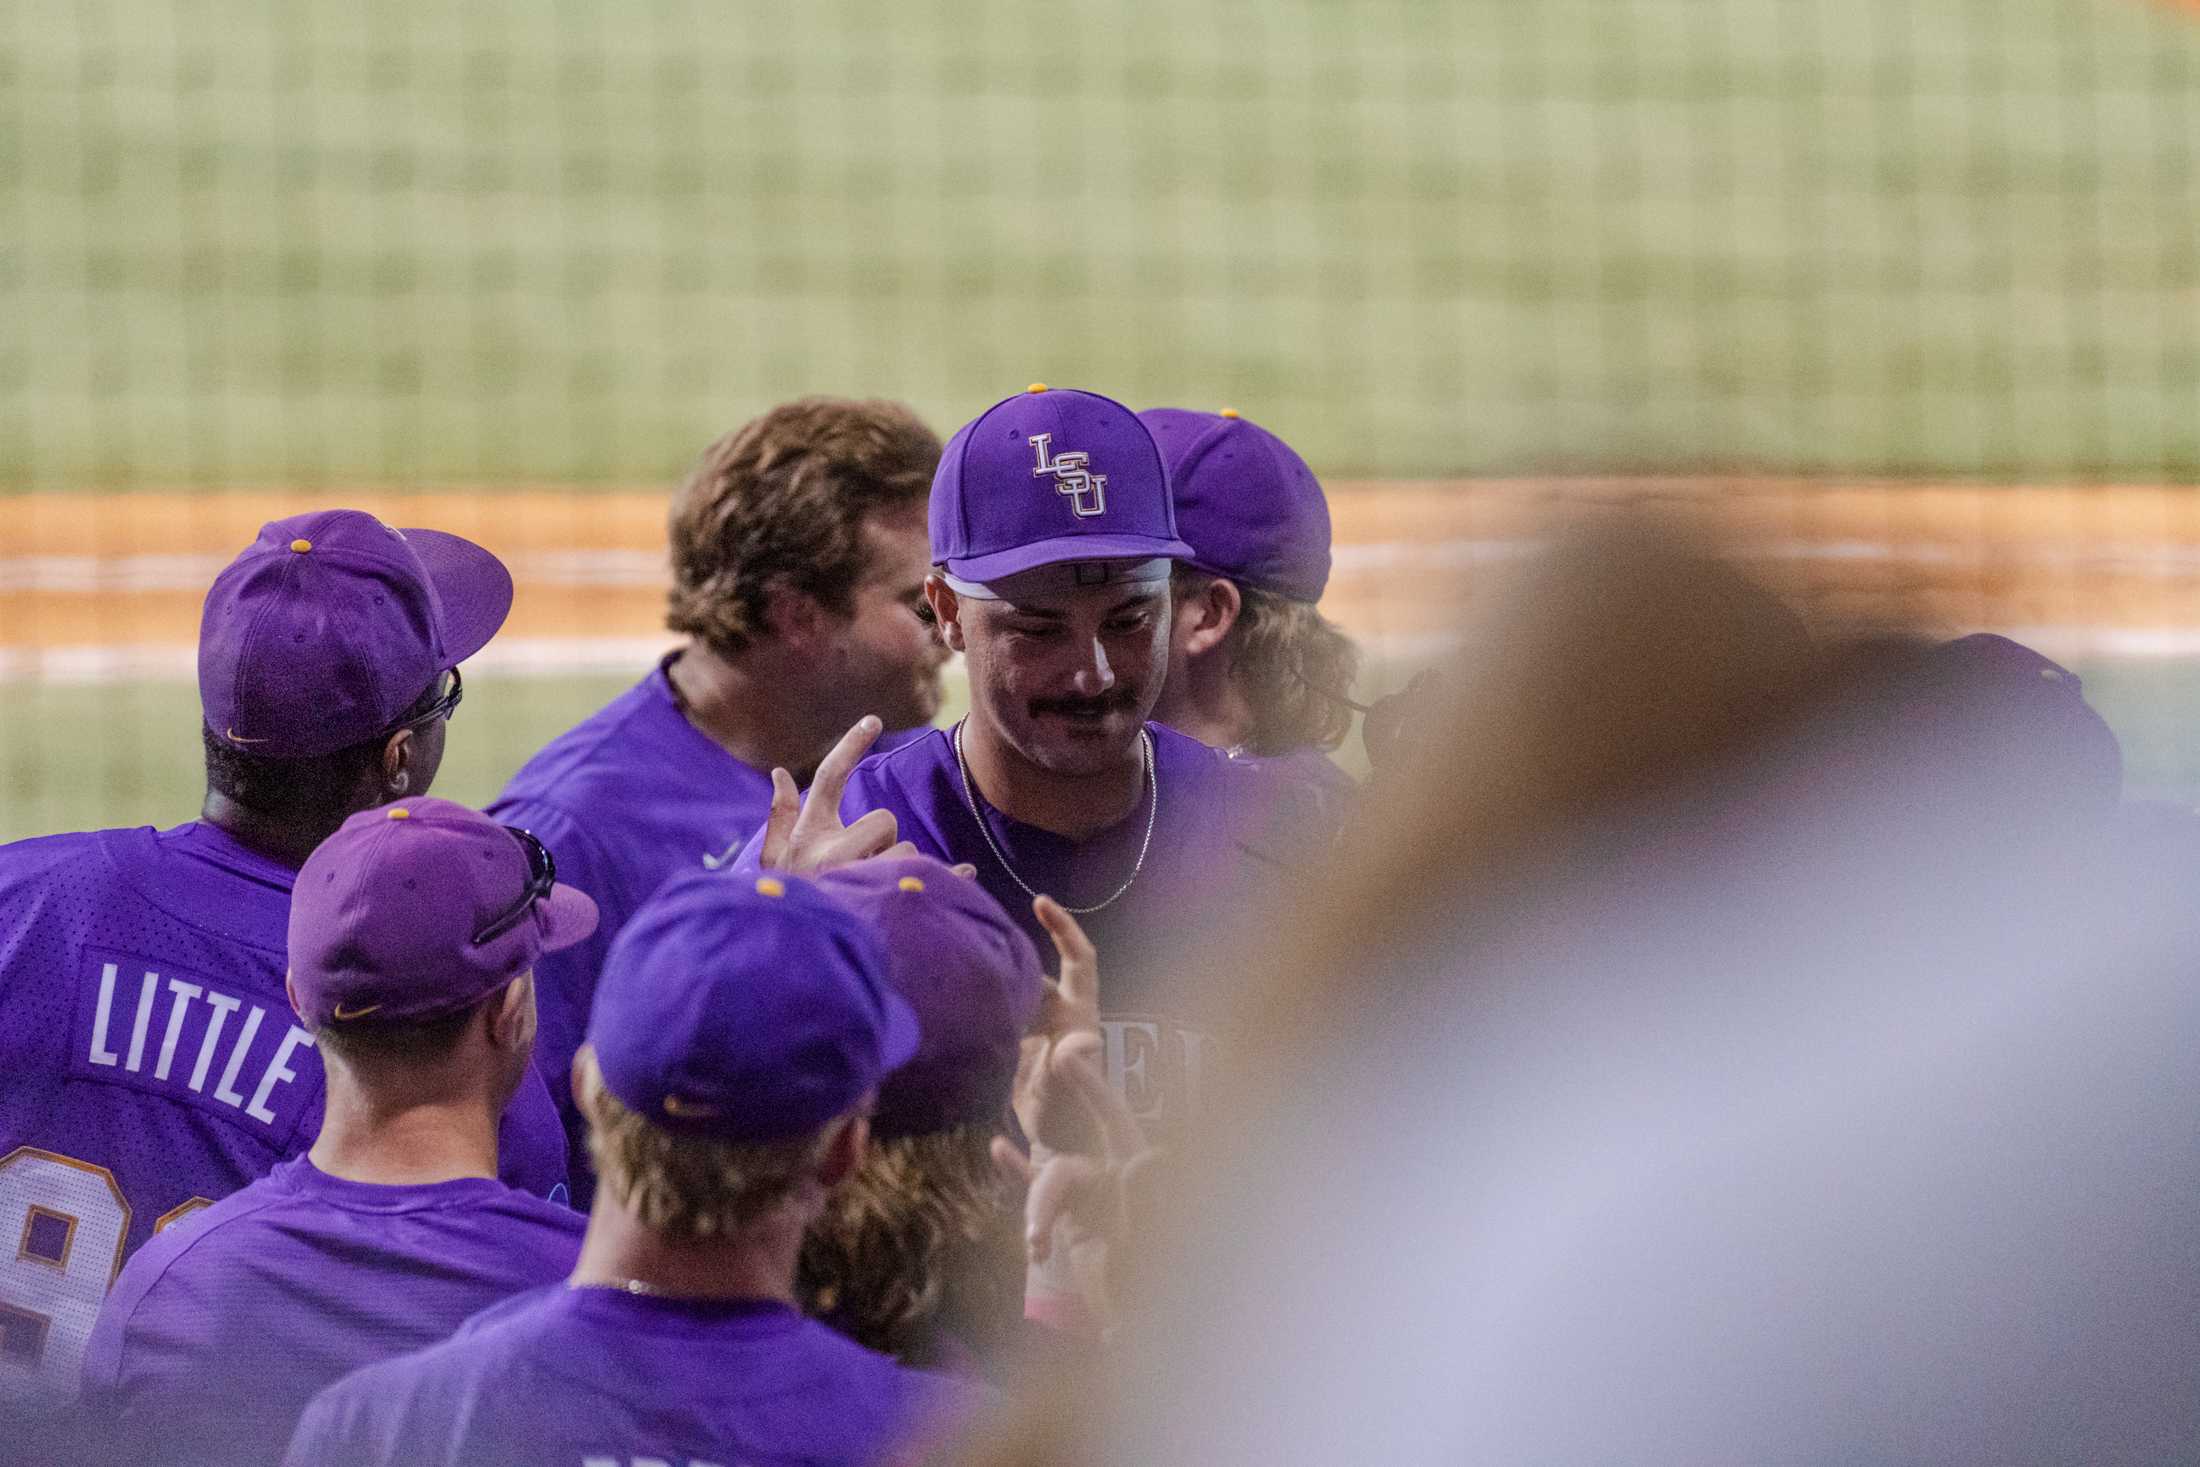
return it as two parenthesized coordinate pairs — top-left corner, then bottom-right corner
(572, 1185), (814, 1304)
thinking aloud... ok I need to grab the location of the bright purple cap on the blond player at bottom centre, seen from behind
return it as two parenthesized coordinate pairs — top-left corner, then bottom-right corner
(587, 871), (917, 1141)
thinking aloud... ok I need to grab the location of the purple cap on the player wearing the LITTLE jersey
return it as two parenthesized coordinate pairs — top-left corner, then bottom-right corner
(198, 510), (513, 759)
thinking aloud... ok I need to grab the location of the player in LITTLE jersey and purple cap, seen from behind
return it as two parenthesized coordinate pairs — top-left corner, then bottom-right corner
(0, 510), (565, 1394)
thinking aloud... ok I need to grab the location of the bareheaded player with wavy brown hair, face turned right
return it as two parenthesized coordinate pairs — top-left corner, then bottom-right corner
(488, 398), (946, 1201)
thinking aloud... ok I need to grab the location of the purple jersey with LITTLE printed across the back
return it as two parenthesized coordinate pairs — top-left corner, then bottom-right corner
(0, 823), (565, 1394)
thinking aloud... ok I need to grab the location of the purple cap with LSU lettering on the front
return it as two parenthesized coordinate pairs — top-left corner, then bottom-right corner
(928, 383), (1192, 583)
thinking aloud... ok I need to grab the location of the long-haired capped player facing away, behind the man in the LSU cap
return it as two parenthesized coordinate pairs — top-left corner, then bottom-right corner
(1140, 407), (1360, 796)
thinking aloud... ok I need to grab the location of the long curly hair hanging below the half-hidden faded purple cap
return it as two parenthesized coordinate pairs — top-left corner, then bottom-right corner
(796, 1126), (1023, 1364)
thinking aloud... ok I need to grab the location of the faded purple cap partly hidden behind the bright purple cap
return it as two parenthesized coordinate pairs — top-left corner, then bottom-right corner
(818, 856), (1045, 1137)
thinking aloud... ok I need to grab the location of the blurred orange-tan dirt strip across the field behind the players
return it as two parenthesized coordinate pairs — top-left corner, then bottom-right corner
(0, 479), (2200, 675)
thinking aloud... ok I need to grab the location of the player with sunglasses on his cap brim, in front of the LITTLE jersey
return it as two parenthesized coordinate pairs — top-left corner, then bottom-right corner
(84, 798), (596, 1463)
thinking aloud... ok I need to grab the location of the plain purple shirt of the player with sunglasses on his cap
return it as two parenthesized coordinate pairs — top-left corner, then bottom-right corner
(84, 1157), (587, 1463)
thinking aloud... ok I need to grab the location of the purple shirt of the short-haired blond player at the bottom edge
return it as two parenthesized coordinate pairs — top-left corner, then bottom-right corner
(284, 1284), (983, 1467)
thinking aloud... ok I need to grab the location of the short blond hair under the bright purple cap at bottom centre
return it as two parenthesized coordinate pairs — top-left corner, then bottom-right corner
(581, 1051), (832, 1240)
